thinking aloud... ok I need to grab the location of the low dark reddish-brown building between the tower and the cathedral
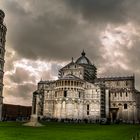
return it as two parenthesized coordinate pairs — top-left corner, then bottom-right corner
(2, 104), (31, 121)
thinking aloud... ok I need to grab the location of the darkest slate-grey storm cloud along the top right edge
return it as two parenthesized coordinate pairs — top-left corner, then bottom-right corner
(65, 0), (140, 24)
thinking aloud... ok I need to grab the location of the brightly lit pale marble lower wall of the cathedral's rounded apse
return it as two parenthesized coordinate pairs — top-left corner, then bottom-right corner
(44, 81), (100, 119)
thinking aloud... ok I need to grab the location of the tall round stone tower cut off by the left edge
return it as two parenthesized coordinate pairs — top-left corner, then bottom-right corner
(0, 10), (7, 120)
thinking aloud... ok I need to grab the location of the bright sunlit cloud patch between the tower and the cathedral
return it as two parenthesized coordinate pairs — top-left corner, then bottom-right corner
(4, 59), (63, 105)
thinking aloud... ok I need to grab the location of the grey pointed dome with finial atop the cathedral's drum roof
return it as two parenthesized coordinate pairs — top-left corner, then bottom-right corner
(76, 51), (92, 65)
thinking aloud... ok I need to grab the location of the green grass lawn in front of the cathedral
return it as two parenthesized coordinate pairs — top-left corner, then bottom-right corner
(0, 122), (140, 140)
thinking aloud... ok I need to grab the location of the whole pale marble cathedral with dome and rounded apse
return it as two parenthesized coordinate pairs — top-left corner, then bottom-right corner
(32, 51), (140, 123)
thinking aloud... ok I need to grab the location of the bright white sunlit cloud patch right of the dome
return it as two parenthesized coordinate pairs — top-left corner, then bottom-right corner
(101, 23), (138, 70)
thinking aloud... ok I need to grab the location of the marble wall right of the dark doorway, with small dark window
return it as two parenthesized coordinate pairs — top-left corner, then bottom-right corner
(111, 91), (138, 122)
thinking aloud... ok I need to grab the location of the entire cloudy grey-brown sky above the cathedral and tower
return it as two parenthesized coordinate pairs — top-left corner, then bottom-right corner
(0, 0), (140, 105)
